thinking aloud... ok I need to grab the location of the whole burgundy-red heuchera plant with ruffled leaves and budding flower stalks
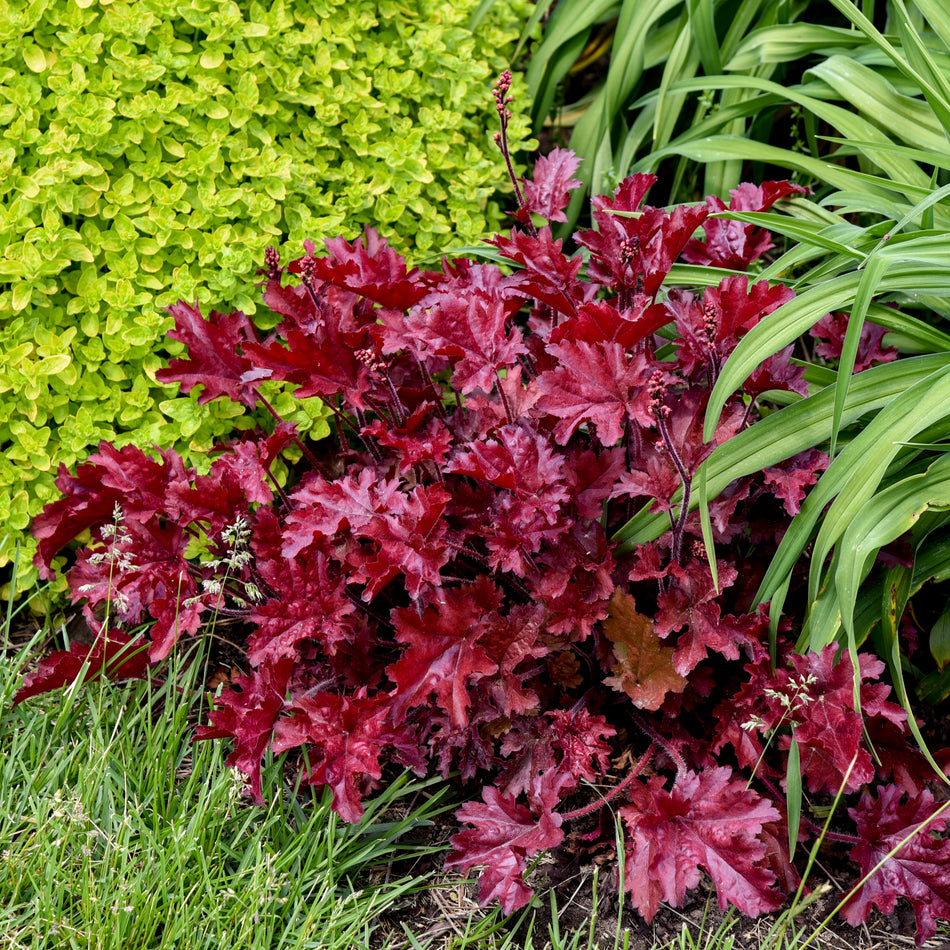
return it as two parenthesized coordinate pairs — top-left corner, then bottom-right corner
(15, 76), (950, 940)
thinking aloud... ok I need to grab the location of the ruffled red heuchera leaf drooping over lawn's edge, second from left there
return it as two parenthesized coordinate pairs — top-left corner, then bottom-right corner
(271, 689), (392, 822)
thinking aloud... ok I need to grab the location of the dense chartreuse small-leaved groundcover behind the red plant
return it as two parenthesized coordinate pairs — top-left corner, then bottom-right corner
(0, 0), (526, 596)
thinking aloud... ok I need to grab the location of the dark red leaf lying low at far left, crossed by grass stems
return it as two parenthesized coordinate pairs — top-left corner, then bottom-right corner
(13, 630), (152, 706)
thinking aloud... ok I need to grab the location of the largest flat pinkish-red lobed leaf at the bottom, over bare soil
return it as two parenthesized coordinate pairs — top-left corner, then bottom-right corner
(620, 768), (781, 923)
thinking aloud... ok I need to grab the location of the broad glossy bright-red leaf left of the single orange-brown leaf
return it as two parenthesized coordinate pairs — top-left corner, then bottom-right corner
(386, 576), (501, 728)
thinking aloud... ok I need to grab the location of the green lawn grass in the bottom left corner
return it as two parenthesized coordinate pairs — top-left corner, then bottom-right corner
(0, 616), (452, 950)
